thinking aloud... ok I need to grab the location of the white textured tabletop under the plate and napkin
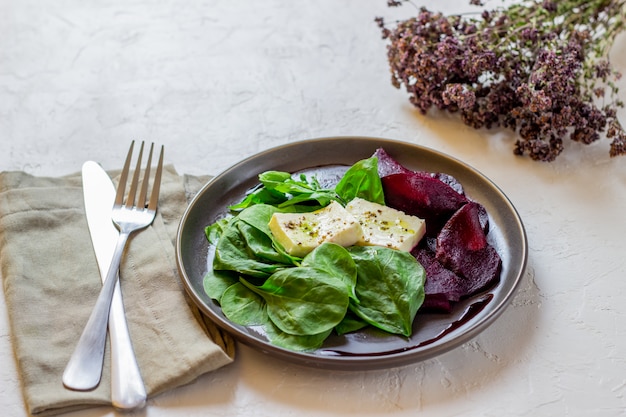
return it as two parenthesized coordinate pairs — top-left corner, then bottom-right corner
(0, 0), (626, 417)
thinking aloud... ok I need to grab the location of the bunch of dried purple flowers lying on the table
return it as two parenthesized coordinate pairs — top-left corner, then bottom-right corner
(376, 0), (626, 161)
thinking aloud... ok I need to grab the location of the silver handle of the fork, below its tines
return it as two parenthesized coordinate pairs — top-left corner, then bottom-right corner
(63, 231), (129, 391)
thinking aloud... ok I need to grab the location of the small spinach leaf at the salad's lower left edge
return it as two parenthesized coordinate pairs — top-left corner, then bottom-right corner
(220, 282), (268, 326)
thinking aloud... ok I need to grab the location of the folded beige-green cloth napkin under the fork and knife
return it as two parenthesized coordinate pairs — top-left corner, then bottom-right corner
(0, 166), (234, 416)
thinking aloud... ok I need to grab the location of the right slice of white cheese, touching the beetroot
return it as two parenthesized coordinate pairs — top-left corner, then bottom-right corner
(346, 198), (426, 252)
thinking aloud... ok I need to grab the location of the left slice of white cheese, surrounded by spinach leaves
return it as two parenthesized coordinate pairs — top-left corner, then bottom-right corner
(269, 201), (363, 257)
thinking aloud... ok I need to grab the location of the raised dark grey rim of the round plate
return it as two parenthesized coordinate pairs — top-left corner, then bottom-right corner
(175, 135), (528, 370)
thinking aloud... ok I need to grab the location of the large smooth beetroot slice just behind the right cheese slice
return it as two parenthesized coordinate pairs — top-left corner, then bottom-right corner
(381, 172), (468, 236)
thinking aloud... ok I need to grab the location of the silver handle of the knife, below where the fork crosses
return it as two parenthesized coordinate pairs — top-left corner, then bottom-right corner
(109, 281), (146, 410)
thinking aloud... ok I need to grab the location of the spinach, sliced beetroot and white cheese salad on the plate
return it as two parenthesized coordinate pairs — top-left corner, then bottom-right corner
(204, 149), (501, 351)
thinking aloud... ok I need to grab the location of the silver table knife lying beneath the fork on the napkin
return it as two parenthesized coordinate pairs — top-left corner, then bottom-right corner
(82, 161), (146, 410)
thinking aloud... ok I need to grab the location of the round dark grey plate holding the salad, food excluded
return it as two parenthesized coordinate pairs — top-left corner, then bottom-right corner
(176, 137), (528, 370)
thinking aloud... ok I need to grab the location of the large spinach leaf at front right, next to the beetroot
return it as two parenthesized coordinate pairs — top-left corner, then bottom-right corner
(348, 246), (425, 337)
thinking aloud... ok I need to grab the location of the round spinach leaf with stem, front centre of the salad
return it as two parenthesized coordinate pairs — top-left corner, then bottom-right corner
(241, 267), (349, 336)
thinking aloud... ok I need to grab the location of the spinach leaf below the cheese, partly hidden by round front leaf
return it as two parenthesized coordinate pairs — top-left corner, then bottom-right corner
(301, 242), (358, 301)
